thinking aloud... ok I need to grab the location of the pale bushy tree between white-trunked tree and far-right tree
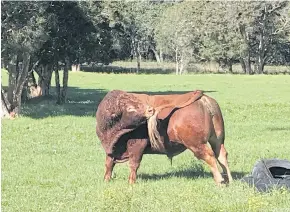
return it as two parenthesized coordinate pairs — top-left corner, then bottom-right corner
(198, 1), (242, 72)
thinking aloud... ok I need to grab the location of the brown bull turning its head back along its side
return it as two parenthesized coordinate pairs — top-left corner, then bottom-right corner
(96, 90), (232, 185)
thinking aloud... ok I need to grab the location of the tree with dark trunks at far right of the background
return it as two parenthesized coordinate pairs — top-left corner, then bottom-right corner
(233, 1), (289, 74)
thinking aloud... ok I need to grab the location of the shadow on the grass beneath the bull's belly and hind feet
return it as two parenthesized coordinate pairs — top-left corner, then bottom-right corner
(138, 164), (247, 180)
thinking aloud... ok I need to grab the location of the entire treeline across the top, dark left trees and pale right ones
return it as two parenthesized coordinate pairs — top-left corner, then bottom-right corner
(1, 0), (290, 117)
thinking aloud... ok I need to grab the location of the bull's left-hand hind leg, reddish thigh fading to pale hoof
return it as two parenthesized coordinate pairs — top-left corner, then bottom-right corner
(188, 144), (224, 185)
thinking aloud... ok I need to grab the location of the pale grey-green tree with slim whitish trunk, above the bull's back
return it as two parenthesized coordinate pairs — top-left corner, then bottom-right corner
(155, 2), (204, 75)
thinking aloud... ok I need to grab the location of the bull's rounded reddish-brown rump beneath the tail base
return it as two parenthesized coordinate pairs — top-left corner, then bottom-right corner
(167, 95), (224, 147)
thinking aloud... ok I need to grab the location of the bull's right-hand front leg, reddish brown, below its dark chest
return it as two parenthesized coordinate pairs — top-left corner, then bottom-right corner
(127, 139), (147, 184)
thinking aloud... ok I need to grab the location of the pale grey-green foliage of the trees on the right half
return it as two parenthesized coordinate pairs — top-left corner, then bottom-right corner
(155, 1), (290, 73)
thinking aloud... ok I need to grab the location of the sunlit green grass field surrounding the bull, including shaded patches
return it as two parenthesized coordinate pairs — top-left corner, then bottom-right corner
(1, 72), (290, 212)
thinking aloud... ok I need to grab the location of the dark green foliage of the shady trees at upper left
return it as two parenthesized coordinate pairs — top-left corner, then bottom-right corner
(1, 2), (112, 64)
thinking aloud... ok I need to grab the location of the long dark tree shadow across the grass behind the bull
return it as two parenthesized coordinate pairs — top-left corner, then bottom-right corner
(21, 87), (216, 119)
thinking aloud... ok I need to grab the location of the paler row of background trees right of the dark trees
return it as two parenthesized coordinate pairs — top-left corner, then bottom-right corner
(106, 1), (290, 74)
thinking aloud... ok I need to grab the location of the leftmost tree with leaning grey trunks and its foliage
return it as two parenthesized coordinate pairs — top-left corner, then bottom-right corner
(1, 1), (48, 115)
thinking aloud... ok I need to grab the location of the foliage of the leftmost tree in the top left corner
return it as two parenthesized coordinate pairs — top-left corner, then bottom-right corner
(1, 1), (48, 60)
